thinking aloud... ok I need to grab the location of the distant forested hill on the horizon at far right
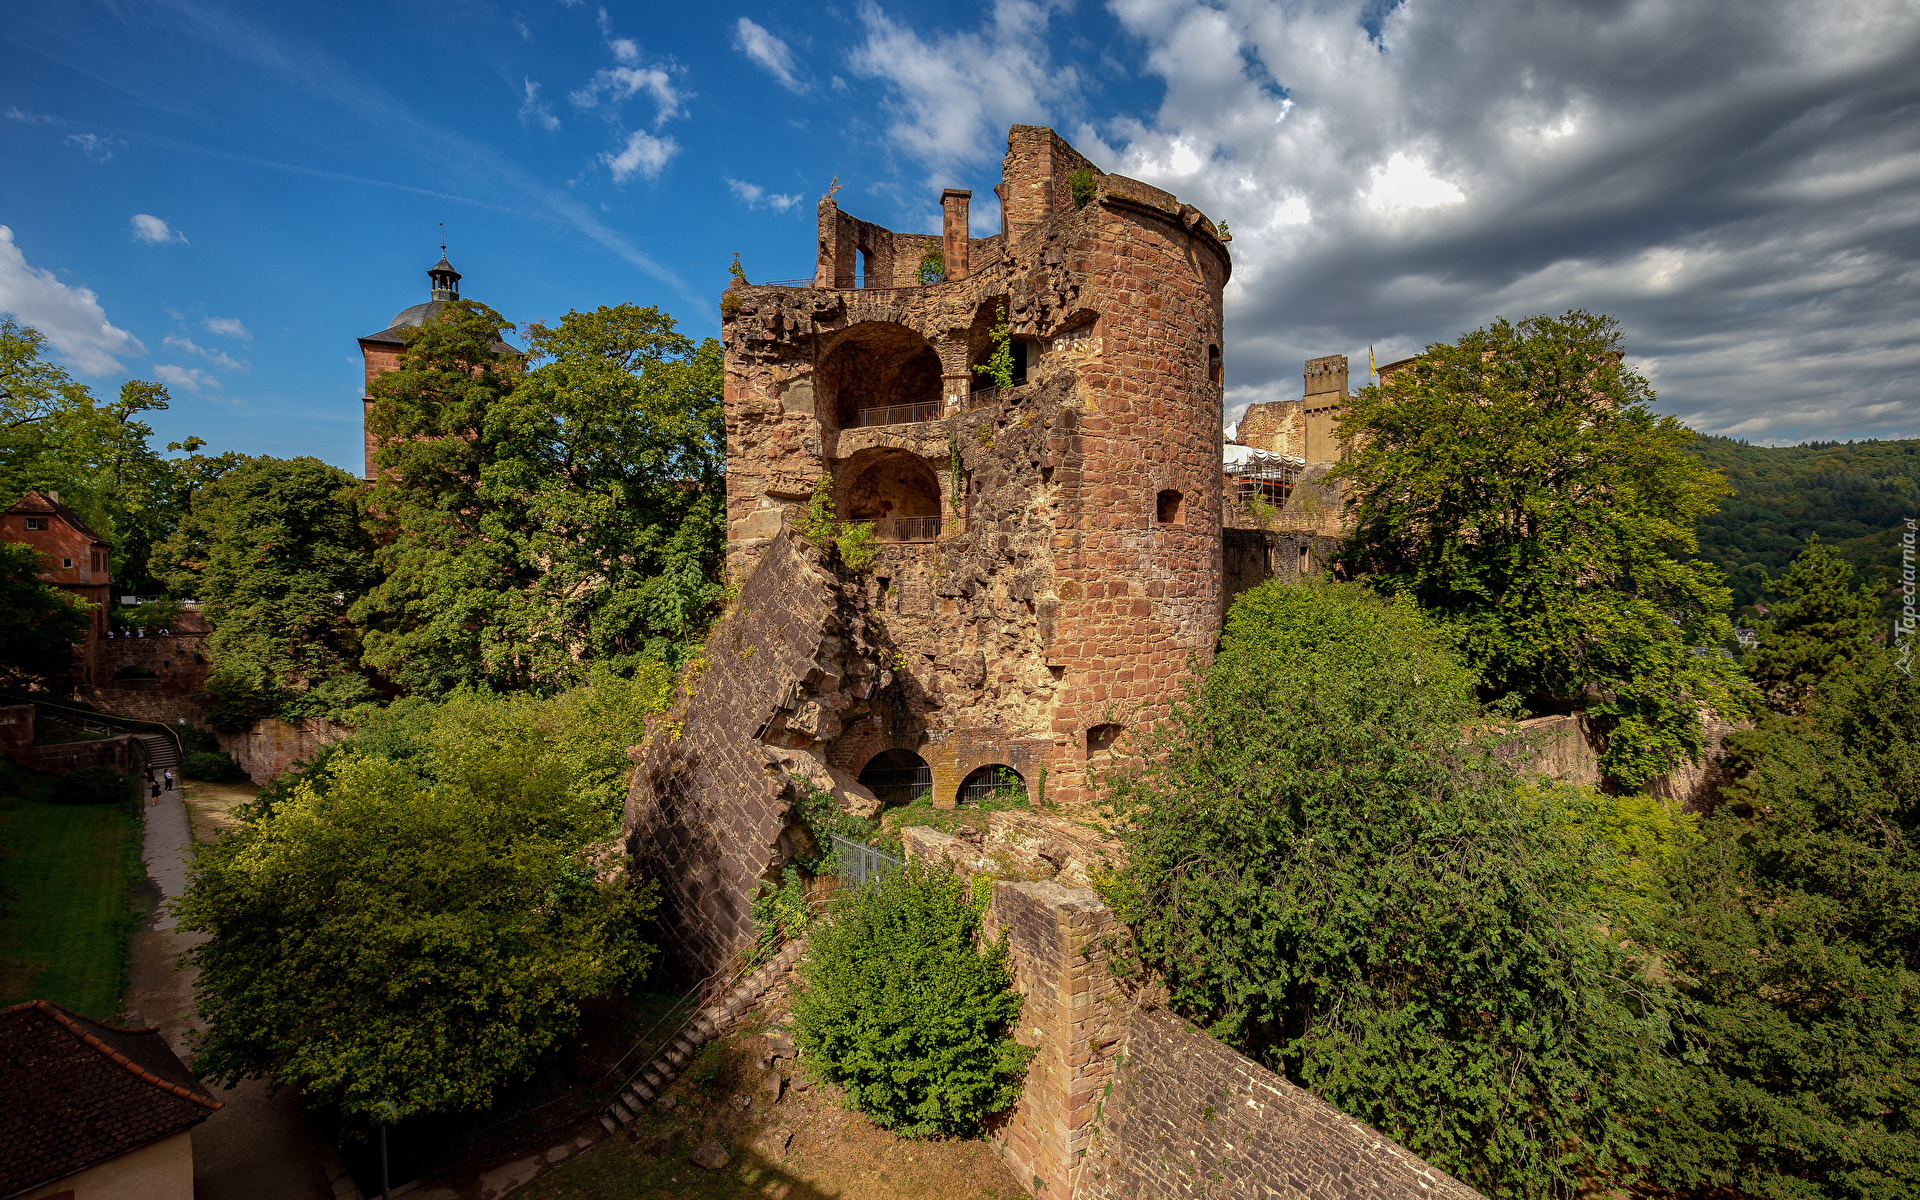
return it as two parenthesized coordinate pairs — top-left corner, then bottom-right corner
(1693, 434), (1920, 618)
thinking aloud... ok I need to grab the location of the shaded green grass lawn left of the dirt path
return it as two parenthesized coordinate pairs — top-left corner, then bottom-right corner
(0, 776), (144, 1020)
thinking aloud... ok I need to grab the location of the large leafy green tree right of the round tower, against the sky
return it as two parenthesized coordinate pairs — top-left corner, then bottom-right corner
(1336, 311), (1749, 789)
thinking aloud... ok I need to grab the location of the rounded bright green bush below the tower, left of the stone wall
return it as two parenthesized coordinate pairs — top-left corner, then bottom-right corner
(793, 862), (1033, 1137)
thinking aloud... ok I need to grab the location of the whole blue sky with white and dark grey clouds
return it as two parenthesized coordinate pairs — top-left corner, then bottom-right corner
(0, 0), (1920, 472)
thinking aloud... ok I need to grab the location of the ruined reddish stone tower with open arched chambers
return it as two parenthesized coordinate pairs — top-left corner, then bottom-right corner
(722, 125), (1231, 804)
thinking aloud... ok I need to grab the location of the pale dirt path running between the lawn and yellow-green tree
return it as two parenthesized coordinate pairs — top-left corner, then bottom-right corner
(127, 783), (338, 1200)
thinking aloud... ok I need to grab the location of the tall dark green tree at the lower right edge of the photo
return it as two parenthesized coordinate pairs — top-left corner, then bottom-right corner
(1657, 653), (1920, 1200)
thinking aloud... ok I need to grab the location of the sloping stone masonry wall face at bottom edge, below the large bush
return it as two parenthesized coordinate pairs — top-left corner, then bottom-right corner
(1082, 1006), (1480, 1200)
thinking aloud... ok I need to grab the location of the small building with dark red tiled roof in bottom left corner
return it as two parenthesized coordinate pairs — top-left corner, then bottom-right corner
(0, 1000), (221, 1200)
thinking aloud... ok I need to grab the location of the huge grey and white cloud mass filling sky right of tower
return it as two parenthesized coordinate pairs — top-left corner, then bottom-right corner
(852, 0), (1920, 442)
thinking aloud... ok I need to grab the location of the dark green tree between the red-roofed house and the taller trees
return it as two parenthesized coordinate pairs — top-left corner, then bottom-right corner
(156, 457), (376, 728)
